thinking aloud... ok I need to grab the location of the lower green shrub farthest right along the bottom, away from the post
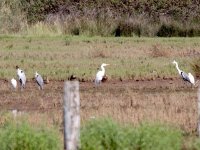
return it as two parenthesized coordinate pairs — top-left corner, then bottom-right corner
(135, 124), (182, 150)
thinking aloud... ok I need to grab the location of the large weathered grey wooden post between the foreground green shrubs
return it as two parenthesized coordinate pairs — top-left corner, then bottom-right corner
(64, 81), (80, 150)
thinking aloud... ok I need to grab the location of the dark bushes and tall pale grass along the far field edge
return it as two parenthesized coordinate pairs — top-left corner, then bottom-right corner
(0, 0), (200, 37)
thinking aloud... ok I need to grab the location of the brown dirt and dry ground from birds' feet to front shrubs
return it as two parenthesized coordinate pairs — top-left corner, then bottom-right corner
(0, 79), (197, 133)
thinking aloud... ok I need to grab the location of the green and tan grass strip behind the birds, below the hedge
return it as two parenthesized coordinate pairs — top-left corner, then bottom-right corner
(0, 36), (200, 81)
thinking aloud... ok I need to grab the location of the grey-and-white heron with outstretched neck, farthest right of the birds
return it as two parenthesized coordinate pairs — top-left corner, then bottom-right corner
(172, 60), (195, 85)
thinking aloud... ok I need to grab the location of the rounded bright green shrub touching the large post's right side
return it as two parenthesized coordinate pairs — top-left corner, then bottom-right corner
(81, 119), (137, 150)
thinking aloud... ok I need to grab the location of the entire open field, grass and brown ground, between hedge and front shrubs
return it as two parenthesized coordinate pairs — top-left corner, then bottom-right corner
(0, 35), (200, 149)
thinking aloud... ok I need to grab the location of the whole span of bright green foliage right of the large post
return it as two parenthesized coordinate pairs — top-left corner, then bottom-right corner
(81, 119), (182, 150)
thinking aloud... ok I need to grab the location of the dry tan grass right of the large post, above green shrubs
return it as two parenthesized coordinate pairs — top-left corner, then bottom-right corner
(82, 83), (197, 133)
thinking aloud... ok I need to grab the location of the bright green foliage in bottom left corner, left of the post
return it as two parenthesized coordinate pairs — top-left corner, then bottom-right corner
(0, 122), (61, 150)
